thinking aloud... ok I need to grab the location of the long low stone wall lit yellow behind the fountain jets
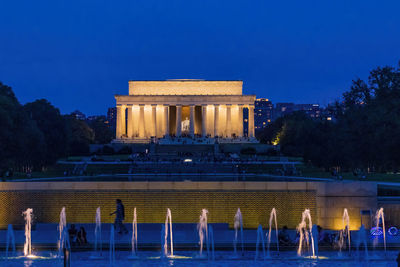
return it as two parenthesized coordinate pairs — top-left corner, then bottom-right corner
(0, 182), (376, 229)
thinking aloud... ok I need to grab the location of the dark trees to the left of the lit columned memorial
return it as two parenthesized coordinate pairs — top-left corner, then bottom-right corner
(0, 82), (113, 176)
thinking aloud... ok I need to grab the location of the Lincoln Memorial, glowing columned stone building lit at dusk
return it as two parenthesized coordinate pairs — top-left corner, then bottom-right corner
(115, 80), (256, 143)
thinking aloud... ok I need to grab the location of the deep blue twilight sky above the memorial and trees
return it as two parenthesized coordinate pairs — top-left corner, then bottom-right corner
(0, 0), (400, 115)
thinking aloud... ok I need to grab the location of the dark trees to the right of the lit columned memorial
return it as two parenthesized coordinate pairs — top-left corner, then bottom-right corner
(258, 62), (400, 172)
